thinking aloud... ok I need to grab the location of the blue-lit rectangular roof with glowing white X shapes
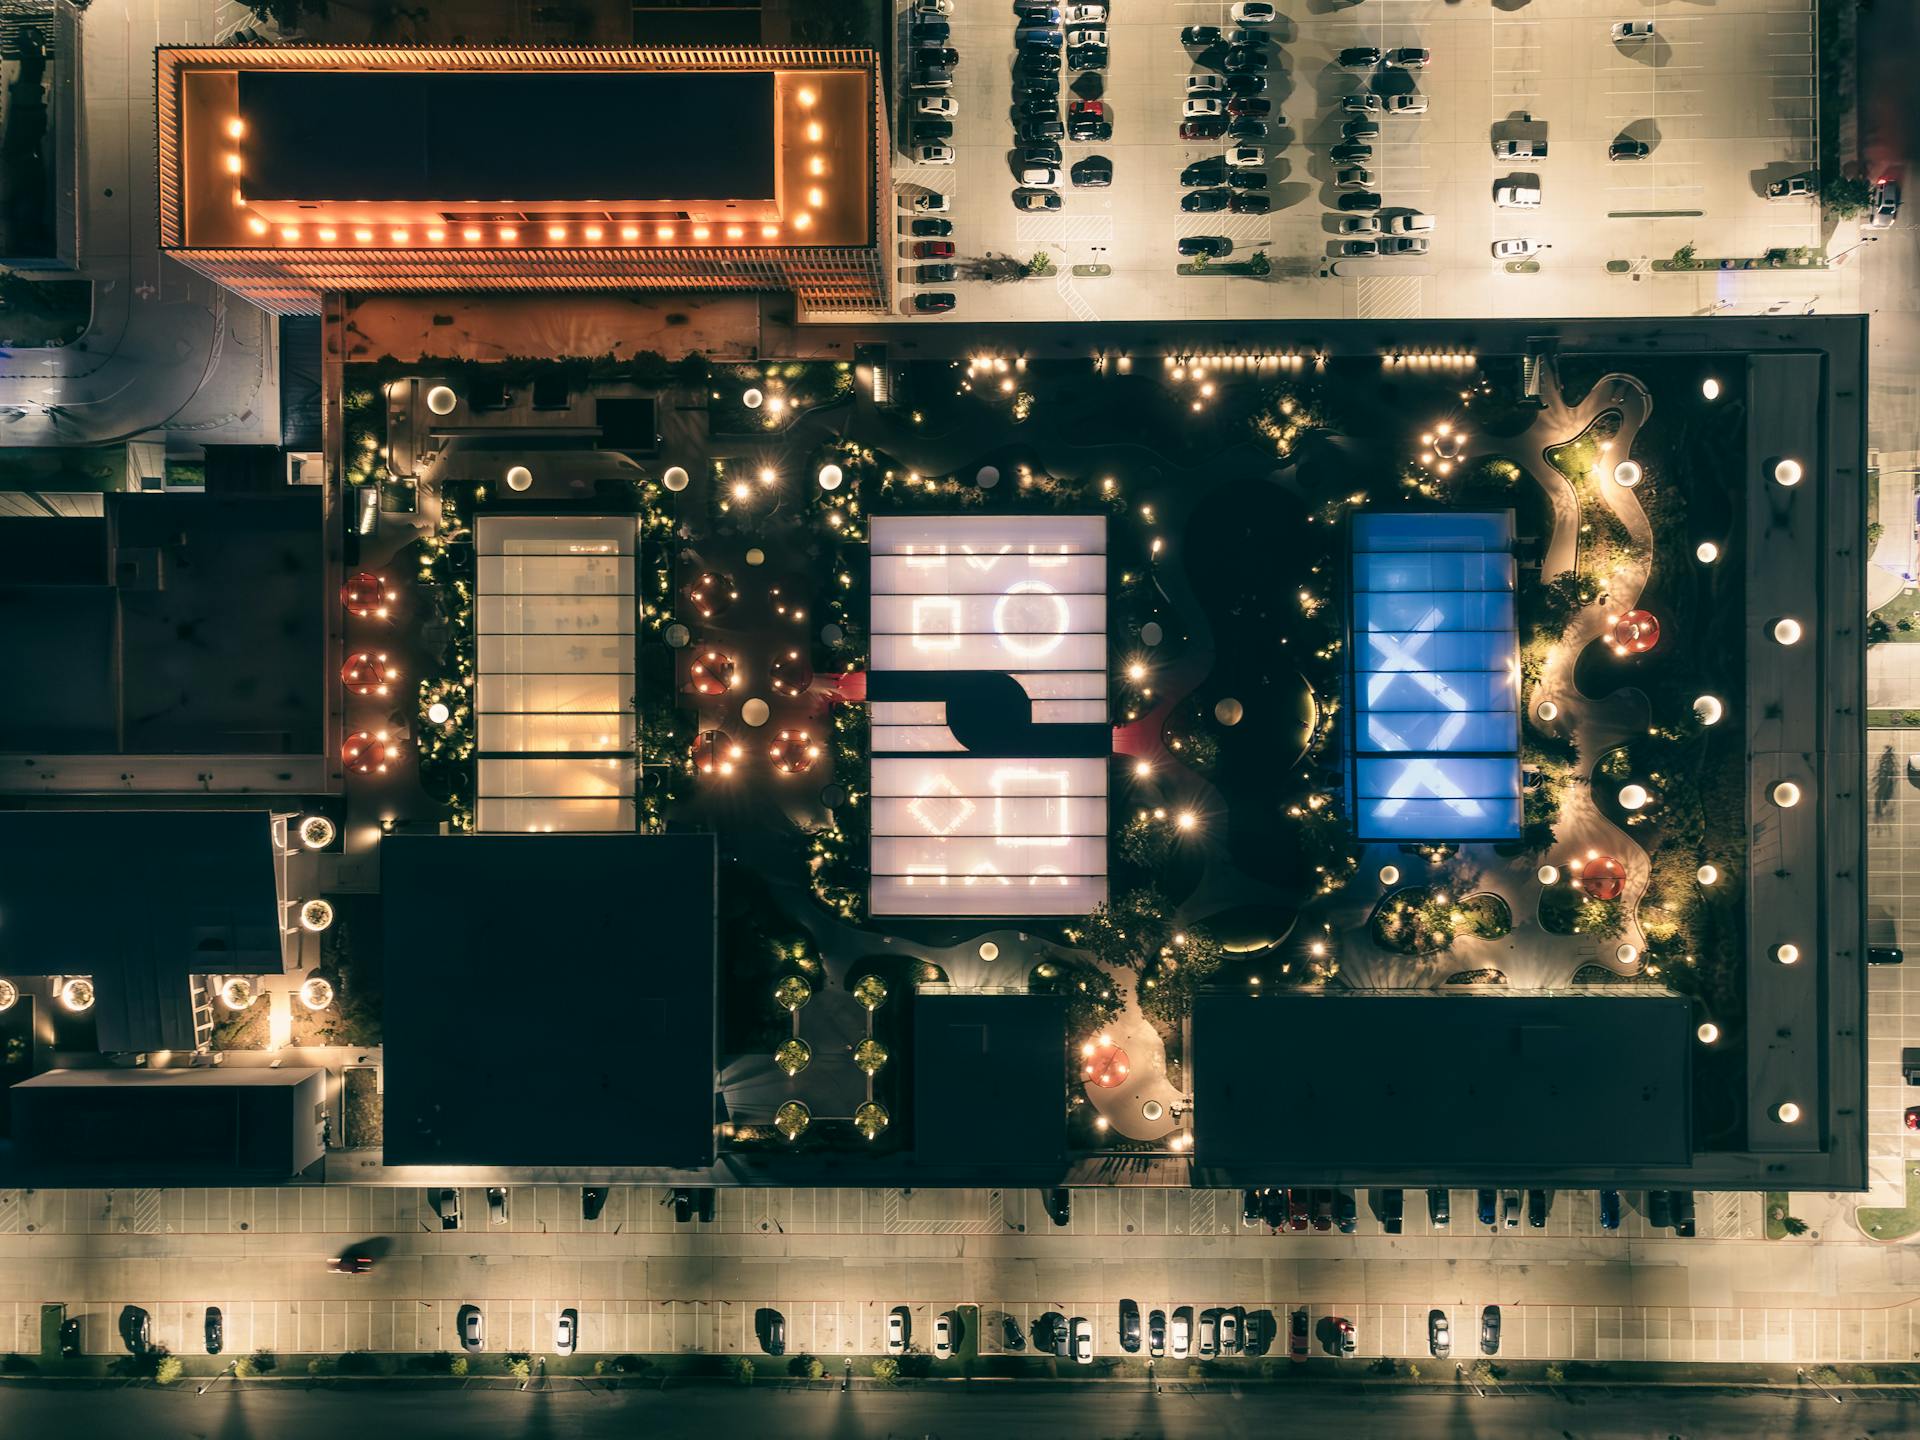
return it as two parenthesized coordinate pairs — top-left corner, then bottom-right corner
(1354, 511), (1521, 841)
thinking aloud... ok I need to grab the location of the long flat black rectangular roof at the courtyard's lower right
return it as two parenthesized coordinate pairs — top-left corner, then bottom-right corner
(1192, 991), (1693, 1185)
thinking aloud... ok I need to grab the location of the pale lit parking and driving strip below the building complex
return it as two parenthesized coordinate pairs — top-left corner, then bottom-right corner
(0, 1187), (1920, 1363)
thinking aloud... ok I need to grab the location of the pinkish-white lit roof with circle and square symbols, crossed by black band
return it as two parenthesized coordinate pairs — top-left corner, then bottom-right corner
(868, 515), (1112, 916)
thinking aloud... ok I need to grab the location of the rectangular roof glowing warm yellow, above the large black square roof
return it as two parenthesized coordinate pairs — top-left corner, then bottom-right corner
(474, 515), (634, 831)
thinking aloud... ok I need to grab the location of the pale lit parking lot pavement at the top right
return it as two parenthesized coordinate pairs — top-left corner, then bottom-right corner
(879, 0), (1841, 321)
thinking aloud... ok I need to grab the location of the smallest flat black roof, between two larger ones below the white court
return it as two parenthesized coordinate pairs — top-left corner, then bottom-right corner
(914, 995), (1068, 1179)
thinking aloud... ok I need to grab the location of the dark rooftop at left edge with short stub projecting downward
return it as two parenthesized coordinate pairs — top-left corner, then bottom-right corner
(0, 810), (284, 1052)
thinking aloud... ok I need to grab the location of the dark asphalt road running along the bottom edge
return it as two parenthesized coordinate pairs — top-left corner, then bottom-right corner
(0, 1384), (1920, 1440)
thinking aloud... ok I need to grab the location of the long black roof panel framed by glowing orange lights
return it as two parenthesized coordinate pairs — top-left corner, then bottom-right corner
(240, 69), (774, 204)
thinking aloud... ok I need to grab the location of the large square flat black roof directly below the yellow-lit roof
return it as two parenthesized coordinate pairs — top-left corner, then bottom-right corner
(380, 835), (718, 1167)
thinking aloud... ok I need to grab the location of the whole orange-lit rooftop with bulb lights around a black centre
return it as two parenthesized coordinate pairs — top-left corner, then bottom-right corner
(159, 46), (877, 265)
